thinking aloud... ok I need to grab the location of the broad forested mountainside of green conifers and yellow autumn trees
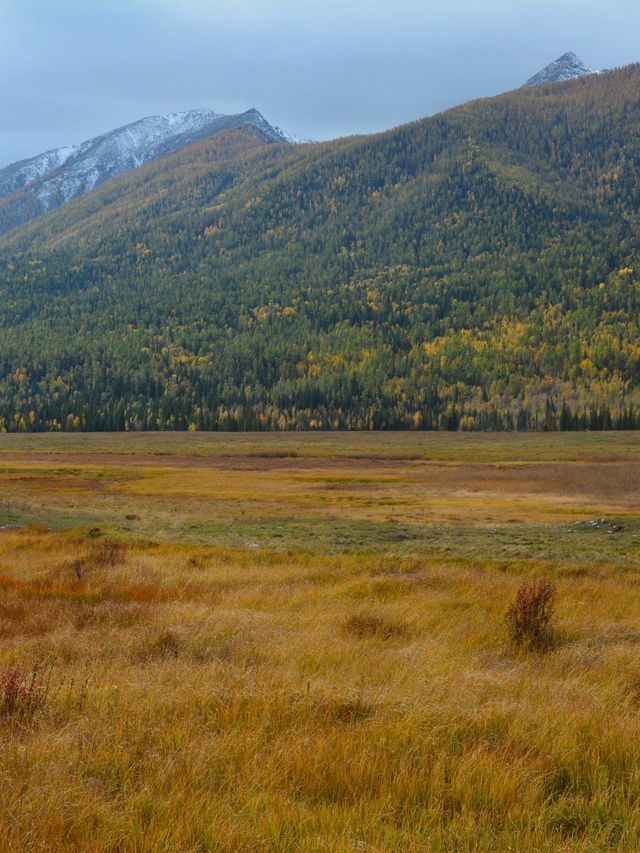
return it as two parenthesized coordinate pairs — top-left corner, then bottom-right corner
(0, 66), (640, 430)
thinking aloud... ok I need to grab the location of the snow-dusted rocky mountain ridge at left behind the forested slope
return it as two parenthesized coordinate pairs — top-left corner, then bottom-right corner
(0, 109), (297, 236)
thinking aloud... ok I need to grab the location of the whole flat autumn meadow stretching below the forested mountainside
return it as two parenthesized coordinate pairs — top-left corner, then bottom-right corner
(0, 433), (640, 853)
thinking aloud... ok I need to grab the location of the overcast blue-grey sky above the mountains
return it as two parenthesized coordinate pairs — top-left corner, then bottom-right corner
(0, 0), (640, 166)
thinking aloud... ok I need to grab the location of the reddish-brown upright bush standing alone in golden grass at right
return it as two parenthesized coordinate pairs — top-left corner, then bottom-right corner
(506, 578), (556, 649)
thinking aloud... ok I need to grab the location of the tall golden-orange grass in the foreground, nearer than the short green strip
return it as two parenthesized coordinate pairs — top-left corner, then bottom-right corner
(0, 531), (640, 851)
